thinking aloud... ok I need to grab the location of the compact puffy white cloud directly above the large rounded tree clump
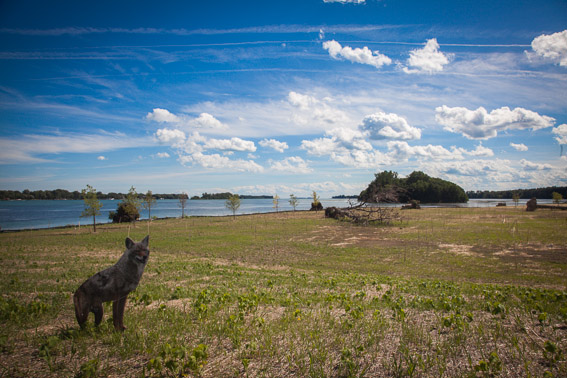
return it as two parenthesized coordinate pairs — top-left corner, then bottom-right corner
(359, 112), (421, 140)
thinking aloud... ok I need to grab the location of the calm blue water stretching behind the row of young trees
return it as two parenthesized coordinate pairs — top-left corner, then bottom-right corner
(0, 198), (551, 230)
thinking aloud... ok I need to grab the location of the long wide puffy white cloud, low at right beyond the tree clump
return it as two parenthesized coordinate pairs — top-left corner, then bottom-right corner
(435, 105), (555, 139)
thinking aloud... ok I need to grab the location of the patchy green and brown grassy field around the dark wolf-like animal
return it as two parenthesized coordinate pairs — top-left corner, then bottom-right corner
(0, 208), (567, 377)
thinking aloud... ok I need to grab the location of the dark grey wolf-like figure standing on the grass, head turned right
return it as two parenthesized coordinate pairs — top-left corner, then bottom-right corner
(73, 235), (150, 332)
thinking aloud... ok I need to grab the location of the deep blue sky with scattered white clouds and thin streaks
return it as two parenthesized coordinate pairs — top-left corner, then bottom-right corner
(0, 0), (567, 197)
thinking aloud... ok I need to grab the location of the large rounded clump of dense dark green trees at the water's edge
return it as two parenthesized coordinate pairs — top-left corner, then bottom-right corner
(358, 171), (468, 203)
